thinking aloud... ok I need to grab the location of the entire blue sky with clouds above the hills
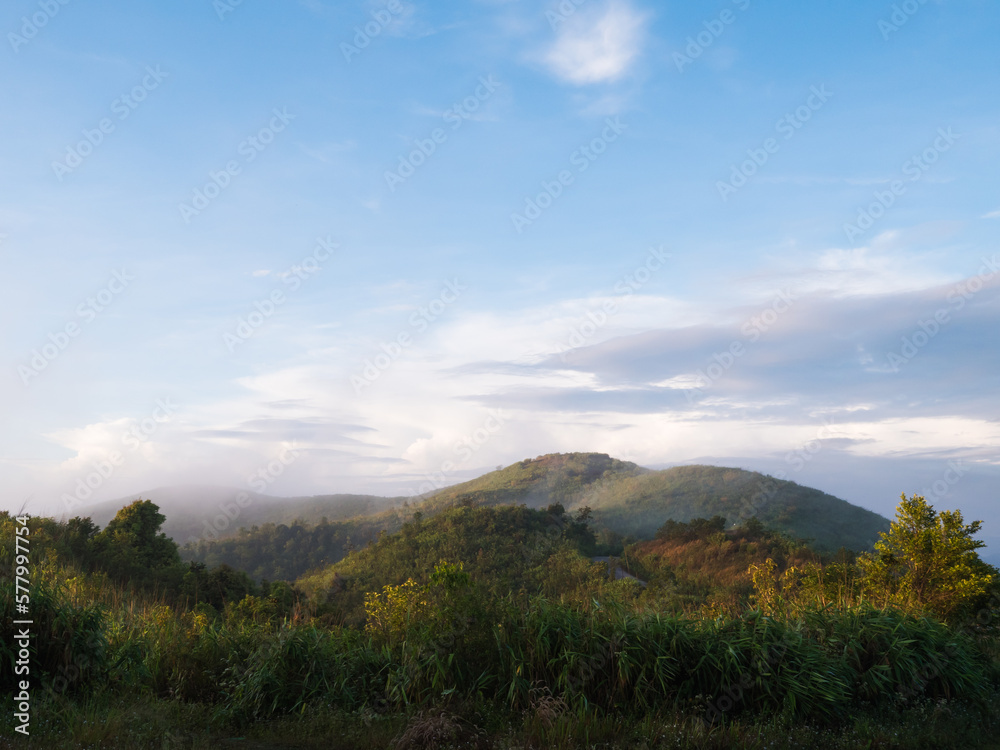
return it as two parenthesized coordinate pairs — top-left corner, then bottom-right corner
(0, 0), (1000, 549)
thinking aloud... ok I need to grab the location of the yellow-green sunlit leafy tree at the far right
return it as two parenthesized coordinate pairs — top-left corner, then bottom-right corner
(859, 494), (998, 620)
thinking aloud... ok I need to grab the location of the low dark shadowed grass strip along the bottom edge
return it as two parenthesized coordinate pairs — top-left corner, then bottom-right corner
(0, 691), (1000, 750)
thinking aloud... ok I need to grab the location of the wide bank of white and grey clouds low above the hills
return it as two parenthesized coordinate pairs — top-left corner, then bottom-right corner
(9, 247), (1000, 512)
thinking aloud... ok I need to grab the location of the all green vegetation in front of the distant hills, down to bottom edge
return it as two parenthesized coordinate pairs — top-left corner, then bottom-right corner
(0, 490), (1000, 748)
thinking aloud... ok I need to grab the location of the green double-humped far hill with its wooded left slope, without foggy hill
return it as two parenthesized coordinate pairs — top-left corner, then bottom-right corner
(176, 453), (888, 592)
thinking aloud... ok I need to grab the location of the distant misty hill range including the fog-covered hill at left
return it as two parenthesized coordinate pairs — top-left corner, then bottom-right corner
(81, 453), (889, 580)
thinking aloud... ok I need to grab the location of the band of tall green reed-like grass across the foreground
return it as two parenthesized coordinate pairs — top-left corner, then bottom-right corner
(0, 568), (1000, 726)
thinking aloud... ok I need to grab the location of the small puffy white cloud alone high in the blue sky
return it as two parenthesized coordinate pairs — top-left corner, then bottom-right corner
(544, 0), (648, 86)
